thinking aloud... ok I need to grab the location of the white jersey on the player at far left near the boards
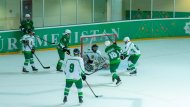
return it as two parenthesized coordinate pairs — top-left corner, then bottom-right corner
(20, 34), (35, 51)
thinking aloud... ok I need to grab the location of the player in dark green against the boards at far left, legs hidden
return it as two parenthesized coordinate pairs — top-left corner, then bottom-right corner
(20, 14), (34, 34)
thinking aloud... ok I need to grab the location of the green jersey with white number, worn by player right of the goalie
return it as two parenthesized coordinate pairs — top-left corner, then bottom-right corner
(105, 44), (121, 64)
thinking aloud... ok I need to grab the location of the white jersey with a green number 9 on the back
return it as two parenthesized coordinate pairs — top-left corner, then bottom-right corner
(65, 56), (85, 80)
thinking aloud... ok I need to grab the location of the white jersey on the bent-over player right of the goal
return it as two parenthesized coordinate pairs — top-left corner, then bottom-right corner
(124, 41), (141, 55)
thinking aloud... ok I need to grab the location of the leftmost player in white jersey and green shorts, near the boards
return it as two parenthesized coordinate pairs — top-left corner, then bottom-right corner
(21, 30), (38, 72)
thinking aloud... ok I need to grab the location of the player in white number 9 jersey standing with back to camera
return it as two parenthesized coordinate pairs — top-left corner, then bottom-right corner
(63, 49), (86, 103)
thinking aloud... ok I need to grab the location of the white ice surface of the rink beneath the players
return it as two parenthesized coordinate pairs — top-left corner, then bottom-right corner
(0, 38), (190, 107)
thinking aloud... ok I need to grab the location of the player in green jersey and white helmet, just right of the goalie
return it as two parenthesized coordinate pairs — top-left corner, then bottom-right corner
(105, 41), (121, 85)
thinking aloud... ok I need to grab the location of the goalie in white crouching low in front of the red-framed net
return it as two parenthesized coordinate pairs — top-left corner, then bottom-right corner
(83, 44), (108, 72)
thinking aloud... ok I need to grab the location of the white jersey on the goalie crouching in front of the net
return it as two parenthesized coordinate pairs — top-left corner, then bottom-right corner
(85, 50), (102, 60)
